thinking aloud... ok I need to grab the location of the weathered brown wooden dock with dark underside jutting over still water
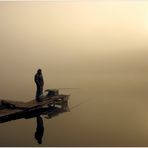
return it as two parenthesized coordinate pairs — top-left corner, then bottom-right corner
(0, 95), (69, 123)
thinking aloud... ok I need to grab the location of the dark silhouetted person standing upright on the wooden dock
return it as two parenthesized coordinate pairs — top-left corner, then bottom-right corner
(34, 69), (44, 101)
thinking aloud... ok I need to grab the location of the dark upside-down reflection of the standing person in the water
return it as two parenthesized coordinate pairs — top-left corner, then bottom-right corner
(35, 116), (44, 144)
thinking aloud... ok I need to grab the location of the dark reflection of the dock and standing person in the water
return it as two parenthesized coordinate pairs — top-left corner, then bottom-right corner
(0, 100), (70, 144)
